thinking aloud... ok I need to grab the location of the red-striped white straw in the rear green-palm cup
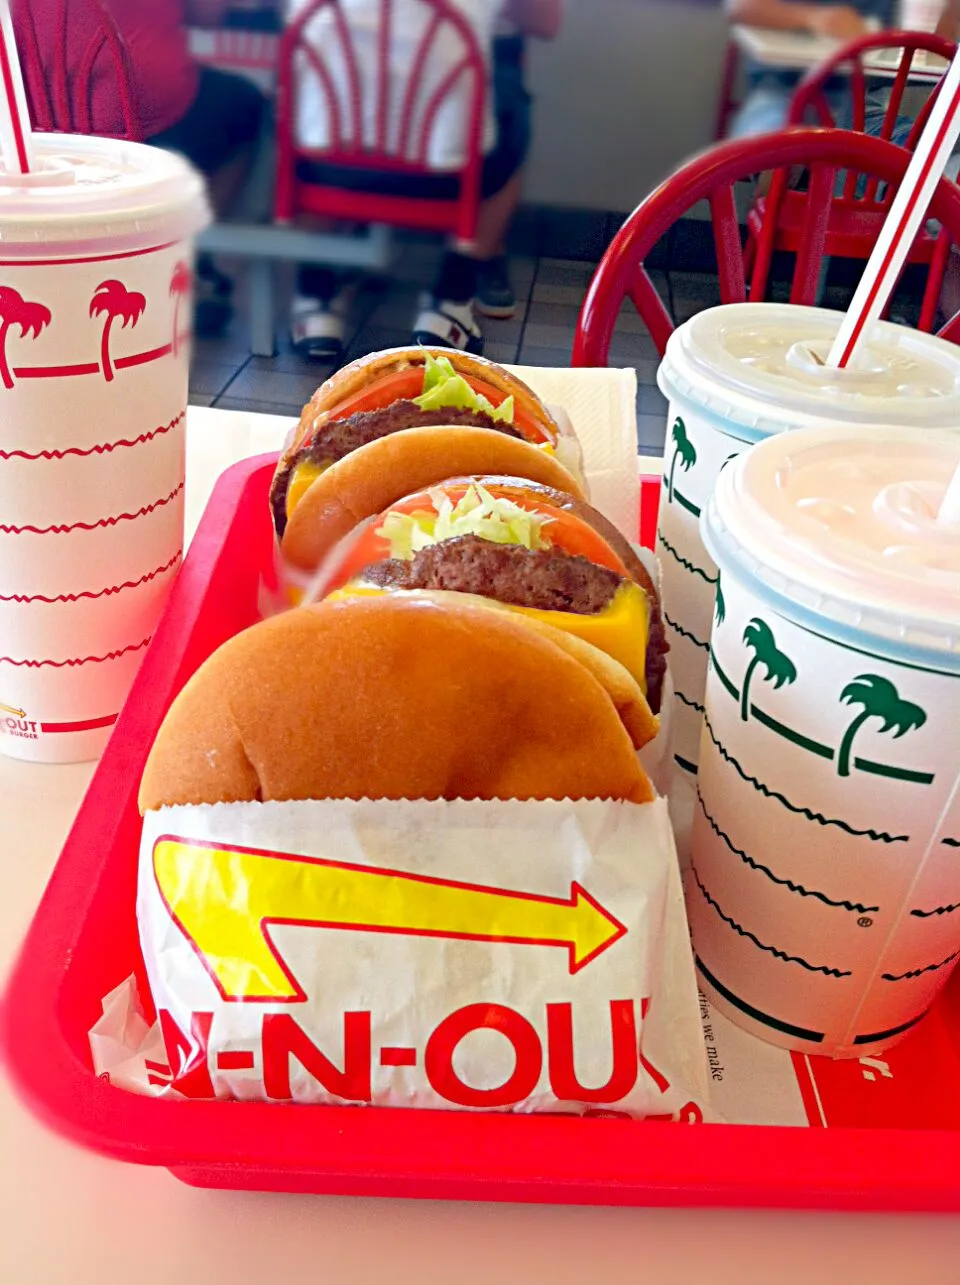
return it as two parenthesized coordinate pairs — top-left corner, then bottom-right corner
(826, 53), (960, 366)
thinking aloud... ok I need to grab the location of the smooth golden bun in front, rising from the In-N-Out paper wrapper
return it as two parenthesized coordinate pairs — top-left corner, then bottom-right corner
(140, 595), (653, 811)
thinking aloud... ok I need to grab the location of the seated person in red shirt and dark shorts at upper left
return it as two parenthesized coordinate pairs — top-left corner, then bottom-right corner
(21, 0), (265, 334)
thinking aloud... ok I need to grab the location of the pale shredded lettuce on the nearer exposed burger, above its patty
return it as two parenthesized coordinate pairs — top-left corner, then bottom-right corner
(377, 483), (553, 562)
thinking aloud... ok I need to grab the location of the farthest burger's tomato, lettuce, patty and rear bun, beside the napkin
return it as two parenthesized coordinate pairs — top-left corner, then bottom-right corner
(270, 348), (581, 536)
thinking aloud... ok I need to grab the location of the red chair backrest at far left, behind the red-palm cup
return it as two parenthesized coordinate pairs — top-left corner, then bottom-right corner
(13, 0), (143, 141)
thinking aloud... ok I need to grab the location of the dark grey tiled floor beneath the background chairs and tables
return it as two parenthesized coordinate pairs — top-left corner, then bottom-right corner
(190, 227), (693, 451)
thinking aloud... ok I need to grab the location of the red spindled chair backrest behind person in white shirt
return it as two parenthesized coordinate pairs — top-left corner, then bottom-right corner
(276, 0), (488, 239)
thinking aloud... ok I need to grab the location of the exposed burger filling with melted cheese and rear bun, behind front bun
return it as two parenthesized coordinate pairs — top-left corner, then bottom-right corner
(324, 477), (667, 713)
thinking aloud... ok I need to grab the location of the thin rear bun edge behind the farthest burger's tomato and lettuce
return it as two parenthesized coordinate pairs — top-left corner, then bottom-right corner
(288, 347), (560, 454)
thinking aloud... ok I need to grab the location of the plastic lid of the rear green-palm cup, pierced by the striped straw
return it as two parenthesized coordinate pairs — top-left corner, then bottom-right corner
(659, 303), (960, 439)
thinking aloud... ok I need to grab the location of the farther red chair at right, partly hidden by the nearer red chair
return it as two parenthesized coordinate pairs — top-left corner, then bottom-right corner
(747, 31), (956, 317)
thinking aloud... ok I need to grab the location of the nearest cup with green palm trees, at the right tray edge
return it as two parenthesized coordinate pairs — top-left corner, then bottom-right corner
(686, 428), (960, 1058)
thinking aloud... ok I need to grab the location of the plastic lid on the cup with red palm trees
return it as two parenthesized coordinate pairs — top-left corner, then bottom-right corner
(0, 134), (209, 257)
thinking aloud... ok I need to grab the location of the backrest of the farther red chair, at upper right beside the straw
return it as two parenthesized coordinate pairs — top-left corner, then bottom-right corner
(787, 31), (956, 150)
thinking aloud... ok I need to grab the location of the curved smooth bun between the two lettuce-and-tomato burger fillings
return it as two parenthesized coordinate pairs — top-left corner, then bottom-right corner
(280, 428), (583, 571)
